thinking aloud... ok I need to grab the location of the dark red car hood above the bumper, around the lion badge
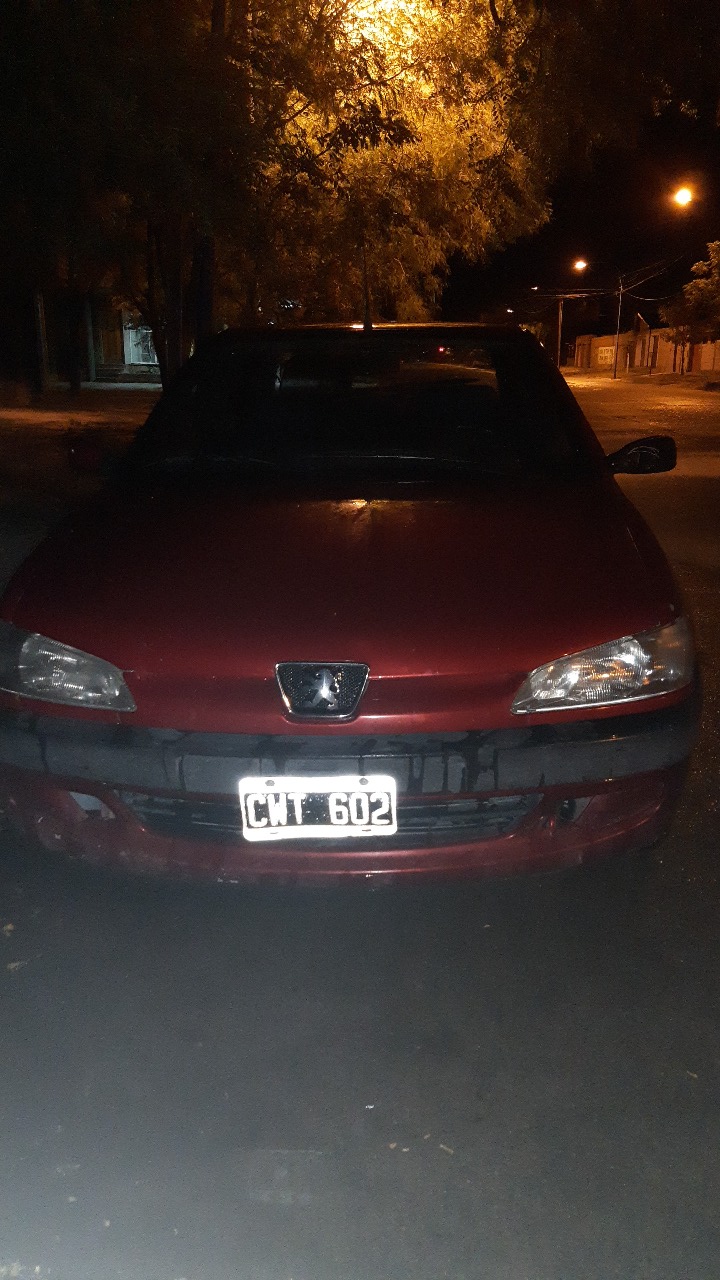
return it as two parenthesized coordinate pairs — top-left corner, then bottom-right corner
(4, 481), (674, 732)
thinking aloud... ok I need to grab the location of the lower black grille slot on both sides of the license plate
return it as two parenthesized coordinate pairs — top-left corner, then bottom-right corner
(118, 791), (539, 851)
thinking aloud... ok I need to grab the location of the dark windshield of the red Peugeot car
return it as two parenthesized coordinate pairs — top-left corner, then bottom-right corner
(124, 330), (594, 481)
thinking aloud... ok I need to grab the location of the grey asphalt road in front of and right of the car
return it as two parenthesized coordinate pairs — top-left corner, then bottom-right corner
(0, 379), (720, 1280)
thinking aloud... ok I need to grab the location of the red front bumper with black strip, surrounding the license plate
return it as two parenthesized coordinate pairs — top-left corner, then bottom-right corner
(0, 691), (700, 879)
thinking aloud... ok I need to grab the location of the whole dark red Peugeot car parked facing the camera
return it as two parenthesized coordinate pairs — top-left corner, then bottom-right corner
(0, 325), (698, 881)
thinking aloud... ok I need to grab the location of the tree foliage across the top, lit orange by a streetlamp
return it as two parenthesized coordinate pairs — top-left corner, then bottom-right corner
(0, 0), (720, 378)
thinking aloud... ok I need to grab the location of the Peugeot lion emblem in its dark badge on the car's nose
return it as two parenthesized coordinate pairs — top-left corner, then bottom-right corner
(275, 662), (369, 721)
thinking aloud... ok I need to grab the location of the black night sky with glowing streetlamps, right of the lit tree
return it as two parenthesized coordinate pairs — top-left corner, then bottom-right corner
(443, 115), (720, 333)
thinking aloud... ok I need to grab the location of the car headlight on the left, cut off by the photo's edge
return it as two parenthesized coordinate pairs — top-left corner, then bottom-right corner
(0, 622), (136, 712)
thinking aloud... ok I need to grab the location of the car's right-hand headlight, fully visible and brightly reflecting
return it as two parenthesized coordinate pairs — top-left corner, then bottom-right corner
(512, 618), (694, 716)
